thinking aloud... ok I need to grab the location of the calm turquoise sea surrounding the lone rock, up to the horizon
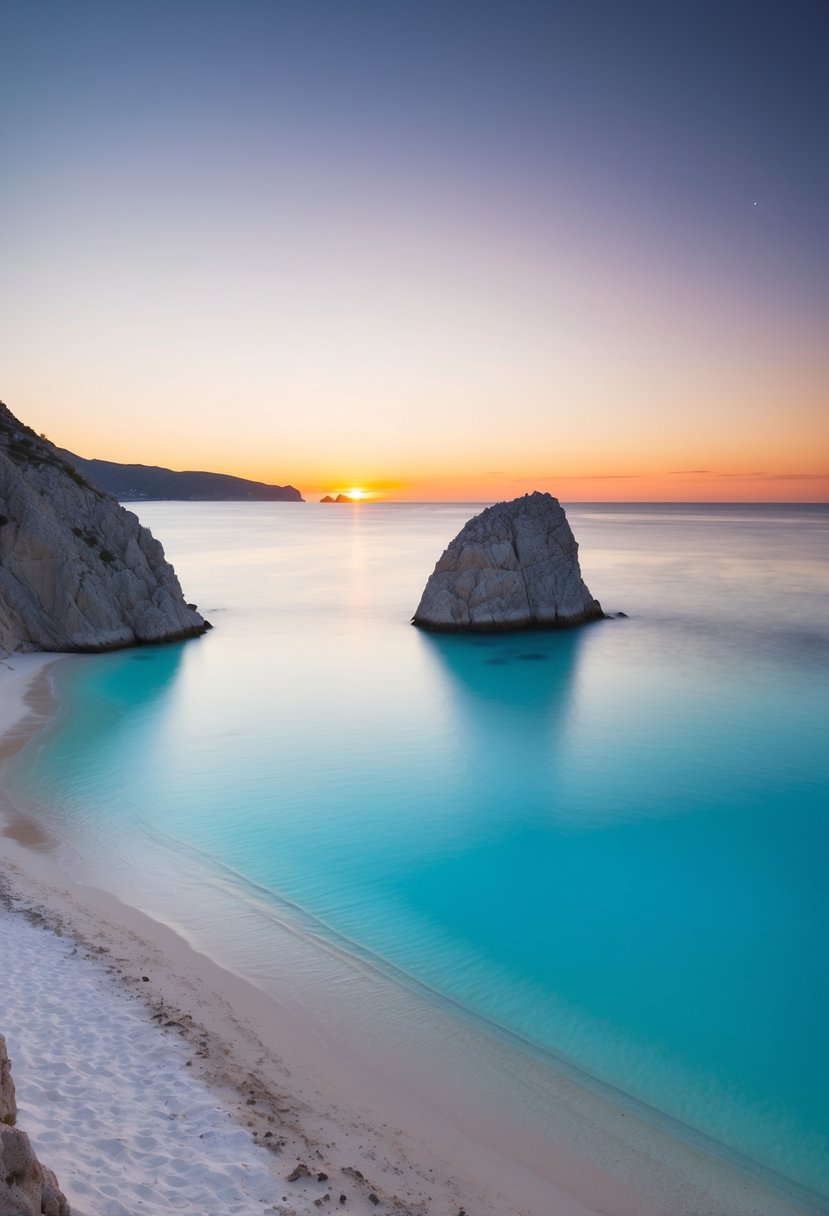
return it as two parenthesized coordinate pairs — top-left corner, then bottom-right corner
(8, 503), (829, 1197)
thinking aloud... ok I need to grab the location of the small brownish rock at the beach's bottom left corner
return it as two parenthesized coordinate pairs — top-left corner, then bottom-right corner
(0, 1035), (69, 1216)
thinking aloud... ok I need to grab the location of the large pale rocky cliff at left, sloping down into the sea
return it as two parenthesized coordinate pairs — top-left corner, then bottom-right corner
(0, 402), (209, 652)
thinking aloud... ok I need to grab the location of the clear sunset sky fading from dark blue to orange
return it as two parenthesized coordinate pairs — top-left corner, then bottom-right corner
(0, 0), (829, 501)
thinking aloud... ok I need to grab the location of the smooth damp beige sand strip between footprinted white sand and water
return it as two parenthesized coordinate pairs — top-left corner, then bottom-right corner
(0, 655), (822, 1216)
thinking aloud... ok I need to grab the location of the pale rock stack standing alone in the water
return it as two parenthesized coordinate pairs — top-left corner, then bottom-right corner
(413, 491), (604, 631)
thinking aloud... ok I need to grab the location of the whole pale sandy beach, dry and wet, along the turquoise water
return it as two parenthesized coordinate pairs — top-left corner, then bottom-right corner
(0, 655), (822, 1216)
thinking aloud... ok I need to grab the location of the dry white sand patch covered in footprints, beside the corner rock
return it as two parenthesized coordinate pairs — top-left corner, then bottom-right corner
(0, 894), (277, 1216)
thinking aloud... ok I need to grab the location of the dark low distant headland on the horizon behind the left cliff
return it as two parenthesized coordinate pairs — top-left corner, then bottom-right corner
(61, 450), (305, 502)
